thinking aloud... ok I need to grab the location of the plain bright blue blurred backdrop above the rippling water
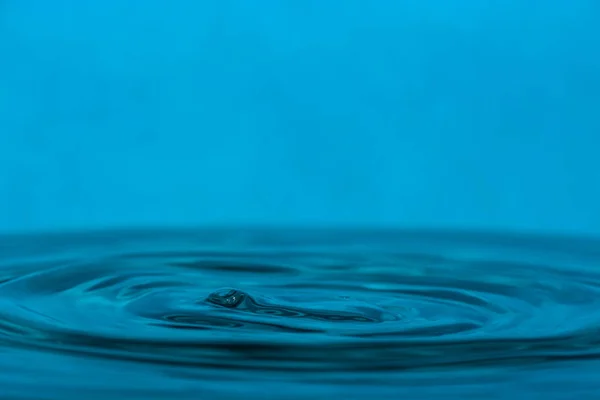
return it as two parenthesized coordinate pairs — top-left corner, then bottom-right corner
(0, 0), (600, 235)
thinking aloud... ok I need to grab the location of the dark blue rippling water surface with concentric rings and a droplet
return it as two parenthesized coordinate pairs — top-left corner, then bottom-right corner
(0, 230), (600, 400)
